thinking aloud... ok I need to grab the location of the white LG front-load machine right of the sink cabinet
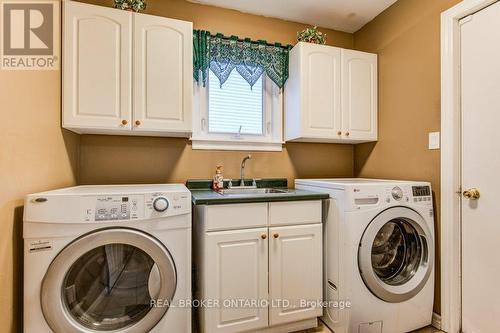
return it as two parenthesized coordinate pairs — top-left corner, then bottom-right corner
(295, 179), (434, 333)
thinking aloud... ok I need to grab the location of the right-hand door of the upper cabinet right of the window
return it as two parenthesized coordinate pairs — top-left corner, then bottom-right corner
(342, 49), (378, 142)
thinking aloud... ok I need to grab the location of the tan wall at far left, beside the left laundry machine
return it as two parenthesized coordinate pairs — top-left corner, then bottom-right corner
(0, 1), (79, 333)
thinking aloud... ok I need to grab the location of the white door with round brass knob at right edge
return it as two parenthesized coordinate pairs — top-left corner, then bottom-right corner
(461, 2), (500, 333)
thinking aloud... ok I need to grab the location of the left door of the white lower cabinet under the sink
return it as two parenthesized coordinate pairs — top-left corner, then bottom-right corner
(202, 228), (268, 333)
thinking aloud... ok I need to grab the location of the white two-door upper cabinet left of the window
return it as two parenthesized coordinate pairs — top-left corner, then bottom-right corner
(63, 1), (193, 137)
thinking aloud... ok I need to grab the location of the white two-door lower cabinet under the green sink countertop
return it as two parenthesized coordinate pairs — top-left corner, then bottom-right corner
(194, 201), (323, 333)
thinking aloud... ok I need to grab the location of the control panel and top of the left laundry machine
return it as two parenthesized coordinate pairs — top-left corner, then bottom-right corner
(24, 184), (191, 224)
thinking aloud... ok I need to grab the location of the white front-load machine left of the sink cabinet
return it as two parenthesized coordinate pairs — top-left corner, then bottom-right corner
(23, 185), (191, 333)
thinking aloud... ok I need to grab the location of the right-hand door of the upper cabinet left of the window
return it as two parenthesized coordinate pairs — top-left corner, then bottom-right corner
(134, 14), (193, 136)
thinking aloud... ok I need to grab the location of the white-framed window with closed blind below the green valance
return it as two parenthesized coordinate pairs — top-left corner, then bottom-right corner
(191, 69), (283, 151)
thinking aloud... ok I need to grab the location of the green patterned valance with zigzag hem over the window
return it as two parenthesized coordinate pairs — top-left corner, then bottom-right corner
(193, 30), (292, 88)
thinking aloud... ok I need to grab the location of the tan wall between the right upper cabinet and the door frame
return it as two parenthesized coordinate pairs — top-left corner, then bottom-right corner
(354, 0), (459, 313)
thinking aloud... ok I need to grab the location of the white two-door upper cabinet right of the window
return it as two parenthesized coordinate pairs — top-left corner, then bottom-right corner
(285, 42), (377, 143)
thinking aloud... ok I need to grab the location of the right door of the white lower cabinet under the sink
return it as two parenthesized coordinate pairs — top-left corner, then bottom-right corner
(269, 224), (323, 326)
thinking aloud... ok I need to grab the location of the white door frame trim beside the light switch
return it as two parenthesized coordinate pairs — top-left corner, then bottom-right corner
(441, 0), (498, 333)
